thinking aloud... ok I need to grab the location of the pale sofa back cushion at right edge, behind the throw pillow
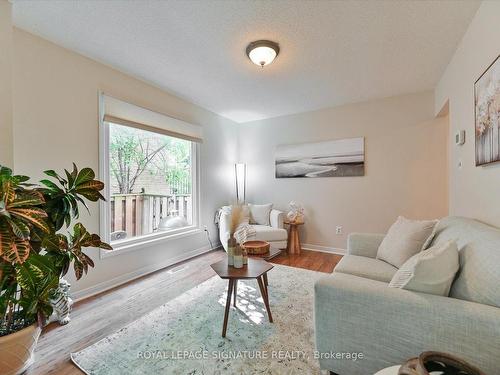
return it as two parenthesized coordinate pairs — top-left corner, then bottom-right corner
(431, 217), (500, 307)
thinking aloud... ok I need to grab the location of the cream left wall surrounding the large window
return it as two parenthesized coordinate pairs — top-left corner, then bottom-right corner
(13, 29), (237, 298)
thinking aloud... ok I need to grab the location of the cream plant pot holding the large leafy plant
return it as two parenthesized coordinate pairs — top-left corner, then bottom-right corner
(0, 324), (42, 375)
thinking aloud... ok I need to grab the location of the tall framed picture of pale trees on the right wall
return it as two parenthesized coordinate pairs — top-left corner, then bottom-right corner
(474, 56), (500, 166)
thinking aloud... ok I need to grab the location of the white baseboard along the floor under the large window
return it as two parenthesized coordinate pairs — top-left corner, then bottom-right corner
(71, 243), (221, 302)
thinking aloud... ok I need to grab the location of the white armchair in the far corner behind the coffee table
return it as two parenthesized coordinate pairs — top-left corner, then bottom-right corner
(219, 206), (288, 251)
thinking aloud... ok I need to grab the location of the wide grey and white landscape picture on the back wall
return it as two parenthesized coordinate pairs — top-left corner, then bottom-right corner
(275, 137), (365, 178)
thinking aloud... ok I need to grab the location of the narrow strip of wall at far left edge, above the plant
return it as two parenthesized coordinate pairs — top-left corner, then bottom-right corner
(0, 0), (13, 167)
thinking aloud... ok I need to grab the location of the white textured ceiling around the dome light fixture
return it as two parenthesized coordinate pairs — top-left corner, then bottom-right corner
(13, 0), (479, 122)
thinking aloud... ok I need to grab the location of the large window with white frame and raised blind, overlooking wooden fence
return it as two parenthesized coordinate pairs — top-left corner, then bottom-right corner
(100, 94), (202, 256)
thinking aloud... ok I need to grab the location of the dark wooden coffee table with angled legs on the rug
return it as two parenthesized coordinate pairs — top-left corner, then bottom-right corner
(210, 258), (274, 337)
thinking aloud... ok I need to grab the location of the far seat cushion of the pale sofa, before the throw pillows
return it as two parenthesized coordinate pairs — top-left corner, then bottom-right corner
(334, 255), (398, 283)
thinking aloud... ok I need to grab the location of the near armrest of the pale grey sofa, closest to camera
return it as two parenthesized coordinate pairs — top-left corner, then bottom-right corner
(315, 273), (500, 375)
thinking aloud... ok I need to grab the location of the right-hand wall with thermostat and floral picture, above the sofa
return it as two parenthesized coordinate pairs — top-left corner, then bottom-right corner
(435, 1), (500, 226)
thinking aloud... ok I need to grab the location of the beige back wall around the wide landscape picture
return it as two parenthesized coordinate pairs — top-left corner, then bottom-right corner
(239, 92), (448, 250)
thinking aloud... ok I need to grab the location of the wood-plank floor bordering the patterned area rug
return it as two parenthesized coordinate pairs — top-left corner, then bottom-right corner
(27, 250), (342, 375)
